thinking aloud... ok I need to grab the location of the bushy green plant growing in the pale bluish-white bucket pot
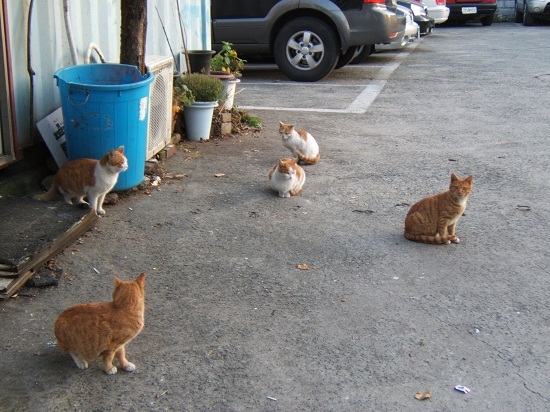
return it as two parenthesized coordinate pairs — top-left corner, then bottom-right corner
(174, 73), (224, 106)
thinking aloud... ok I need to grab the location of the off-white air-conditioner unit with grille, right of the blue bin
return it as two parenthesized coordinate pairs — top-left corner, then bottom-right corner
(145, 56), (174, 159)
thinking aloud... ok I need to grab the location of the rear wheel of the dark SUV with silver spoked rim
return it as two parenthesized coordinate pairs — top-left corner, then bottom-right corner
(273, 17), (340, 82)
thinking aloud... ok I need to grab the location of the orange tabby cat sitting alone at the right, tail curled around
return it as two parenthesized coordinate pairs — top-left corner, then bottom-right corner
(405, 173), (473, 245)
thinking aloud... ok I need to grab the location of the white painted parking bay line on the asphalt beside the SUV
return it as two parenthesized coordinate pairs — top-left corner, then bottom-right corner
(239, 39), (422, 114)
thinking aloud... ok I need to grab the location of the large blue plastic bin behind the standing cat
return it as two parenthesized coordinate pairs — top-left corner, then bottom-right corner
(54, 63), (153, 190)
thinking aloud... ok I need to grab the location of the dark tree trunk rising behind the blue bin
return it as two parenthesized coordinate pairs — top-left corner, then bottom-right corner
(120, 0), (147, 74)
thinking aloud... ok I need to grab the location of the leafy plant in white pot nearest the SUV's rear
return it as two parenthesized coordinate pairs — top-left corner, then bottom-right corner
(210, 41), (246, 110)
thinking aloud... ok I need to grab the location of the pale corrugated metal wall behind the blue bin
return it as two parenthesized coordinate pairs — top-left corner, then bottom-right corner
(7, 0), (210, 147)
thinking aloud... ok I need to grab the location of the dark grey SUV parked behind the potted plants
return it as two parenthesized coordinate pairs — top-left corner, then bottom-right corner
(210, 0), (405, 82)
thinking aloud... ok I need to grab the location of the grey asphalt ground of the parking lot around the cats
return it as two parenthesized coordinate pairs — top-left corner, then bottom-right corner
(0, 23), (550, 411)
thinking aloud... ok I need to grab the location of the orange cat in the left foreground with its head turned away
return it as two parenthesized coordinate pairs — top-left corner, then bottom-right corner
(54, 273), (145, 375)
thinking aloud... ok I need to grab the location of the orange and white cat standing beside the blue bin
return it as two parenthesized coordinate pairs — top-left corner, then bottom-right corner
(34, 146), (128, 215)
